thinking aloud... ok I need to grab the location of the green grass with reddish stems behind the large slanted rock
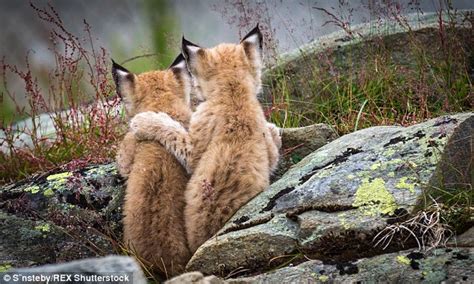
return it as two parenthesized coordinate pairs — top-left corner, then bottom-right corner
(266, 24), (474, 135)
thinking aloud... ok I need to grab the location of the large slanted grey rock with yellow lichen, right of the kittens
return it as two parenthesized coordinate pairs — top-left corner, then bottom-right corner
(188, 113), (474, 275)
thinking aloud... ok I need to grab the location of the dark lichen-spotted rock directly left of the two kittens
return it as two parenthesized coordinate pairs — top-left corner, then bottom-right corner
(0, 164), (123, 267)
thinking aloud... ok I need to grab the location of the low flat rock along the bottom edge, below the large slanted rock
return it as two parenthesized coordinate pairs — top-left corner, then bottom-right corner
(166, 248), (474, 284)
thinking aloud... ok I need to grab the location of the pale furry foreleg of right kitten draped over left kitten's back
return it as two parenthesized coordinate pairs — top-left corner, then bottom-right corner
(130, 111), (192, 173)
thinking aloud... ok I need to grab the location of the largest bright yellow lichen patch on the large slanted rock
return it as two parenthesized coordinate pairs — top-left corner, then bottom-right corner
(352, 178), (398, 216)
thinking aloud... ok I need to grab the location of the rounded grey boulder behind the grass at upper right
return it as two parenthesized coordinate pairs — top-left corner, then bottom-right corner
(263, 10), (472, 103)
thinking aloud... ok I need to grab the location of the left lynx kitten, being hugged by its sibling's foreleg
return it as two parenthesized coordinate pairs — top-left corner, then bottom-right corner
(112, 55), (191, 276)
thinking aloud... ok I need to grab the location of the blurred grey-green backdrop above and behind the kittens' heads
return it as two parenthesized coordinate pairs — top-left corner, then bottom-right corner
(0, 0), (474, 114)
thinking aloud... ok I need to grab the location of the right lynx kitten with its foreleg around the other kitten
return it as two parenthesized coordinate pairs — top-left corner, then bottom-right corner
(131, 26), (281, 252)
